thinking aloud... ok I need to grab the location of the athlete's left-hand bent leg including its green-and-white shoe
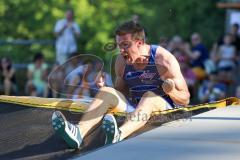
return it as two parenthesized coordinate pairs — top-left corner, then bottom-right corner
(52, 87), (127, 148)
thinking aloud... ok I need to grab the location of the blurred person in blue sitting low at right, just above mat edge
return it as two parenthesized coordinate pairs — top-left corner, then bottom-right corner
(198, 71), (226, 103)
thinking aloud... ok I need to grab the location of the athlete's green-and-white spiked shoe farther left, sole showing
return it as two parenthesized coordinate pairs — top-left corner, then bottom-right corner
(52, 111), (82, 149)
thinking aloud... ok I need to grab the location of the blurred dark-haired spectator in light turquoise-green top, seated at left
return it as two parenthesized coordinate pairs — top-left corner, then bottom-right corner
(26, 52), (48, 97)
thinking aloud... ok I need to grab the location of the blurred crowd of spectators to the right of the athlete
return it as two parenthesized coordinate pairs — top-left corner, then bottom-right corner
(159, 24), (240, 103)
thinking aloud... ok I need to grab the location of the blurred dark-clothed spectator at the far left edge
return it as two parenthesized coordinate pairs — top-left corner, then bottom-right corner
(0, 57), (17, 95)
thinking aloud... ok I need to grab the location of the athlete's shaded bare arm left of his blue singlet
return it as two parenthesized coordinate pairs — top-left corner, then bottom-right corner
(114, 55), (128, 96)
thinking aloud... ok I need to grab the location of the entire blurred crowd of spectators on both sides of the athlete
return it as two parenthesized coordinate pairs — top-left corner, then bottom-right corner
(0, 10), (240, 103)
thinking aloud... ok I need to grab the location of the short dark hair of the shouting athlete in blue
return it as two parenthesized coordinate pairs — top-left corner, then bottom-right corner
(115, 21), (145, 41)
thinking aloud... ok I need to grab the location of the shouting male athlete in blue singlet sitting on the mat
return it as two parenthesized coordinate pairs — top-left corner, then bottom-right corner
(52, 22), (190, 148)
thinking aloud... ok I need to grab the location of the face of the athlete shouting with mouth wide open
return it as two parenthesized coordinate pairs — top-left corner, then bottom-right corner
(116, 34), (143, 63)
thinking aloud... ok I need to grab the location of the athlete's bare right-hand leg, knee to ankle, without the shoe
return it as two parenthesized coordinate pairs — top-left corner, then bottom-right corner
(119, 91), (167, 140)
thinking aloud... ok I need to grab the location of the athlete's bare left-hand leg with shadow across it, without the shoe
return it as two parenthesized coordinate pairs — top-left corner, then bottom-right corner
(79, 87), (127, 137)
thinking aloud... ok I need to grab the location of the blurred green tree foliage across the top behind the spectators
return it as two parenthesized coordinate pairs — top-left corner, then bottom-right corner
(0, 0), (224, 63)
